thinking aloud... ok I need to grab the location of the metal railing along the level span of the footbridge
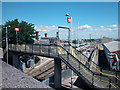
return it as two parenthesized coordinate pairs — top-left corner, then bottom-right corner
(9, 44), (58, 56)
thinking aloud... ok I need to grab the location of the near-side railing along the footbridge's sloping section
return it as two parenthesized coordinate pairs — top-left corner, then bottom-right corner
(58, 47), (119, 88)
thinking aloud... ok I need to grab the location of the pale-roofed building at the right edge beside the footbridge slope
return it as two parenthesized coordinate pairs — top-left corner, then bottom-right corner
(103, 41), (120, 70)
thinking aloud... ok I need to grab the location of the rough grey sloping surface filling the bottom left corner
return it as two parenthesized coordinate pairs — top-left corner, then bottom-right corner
(0, 56), (50, 89)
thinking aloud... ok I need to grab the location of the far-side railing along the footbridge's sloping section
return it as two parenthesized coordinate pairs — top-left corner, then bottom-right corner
(71, 46), (120, 86)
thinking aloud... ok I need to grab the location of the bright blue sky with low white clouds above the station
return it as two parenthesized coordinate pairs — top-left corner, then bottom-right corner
(2, 2), (118, 39)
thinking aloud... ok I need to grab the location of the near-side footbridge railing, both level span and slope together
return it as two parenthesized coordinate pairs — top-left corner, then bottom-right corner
(9, 44), (119, 88)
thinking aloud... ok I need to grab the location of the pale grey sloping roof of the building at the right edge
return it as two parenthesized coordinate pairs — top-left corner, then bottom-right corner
(104, 41), (120, 52)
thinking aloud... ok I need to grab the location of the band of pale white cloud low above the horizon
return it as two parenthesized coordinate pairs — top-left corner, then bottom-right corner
(35, 24), (118, 39)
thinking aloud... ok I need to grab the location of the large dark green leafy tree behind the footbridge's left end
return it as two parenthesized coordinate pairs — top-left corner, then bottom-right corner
(2, 19), (38, 48)
